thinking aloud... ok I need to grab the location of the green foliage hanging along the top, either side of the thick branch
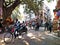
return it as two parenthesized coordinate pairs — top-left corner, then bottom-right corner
(4, 0), (44, 13)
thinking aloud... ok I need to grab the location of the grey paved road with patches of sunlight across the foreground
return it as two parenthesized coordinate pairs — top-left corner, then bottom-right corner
(0, 26), (60, 45)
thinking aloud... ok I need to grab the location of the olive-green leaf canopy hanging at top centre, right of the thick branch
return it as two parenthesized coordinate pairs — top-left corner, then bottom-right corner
(25, 0), (44, 15)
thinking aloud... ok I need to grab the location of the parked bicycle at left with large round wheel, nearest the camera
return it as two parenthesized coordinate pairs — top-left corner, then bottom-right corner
(4, 27), (27, 43)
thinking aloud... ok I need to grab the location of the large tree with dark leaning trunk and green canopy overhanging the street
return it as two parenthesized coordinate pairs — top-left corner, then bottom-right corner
(2, 0), (42, 20)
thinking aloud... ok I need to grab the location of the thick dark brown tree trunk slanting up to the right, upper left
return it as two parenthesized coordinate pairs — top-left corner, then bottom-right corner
(3, 0), (21, 21)
